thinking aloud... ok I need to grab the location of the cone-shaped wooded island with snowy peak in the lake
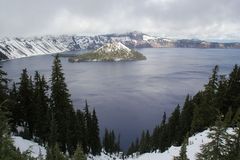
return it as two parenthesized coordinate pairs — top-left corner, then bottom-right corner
(69, 42), (146, 62)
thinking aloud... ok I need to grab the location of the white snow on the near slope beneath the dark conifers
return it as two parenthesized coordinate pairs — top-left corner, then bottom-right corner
(12, 129), (218, 160)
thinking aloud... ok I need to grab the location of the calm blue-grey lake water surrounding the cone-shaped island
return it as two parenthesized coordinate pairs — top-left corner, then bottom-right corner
(1, 49), (240, 148)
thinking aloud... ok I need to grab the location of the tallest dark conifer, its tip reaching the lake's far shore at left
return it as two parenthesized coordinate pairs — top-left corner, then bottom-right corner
(51, 55), (73, 153)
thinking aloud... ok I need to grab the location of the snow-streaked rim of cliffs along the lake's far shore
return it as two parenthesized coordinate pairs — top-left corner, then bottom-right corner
(0, 32), (240, 59)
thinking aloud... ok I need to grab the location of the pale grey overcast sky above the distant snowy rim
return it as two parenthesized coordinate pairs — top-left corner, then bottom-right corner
(0, 0), (240, 40)
